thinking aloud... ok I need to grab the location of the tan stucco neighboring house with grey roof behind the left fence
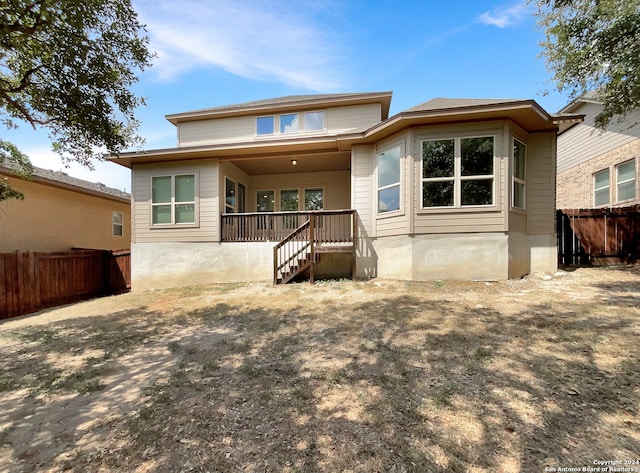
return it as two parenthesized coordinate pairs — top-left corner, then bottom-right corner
(0, 167), (131, 253)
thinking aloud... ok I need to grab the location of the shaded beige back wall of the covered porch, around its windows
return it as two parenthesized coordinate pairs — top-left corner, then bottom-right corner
(247, 170), (351, 208)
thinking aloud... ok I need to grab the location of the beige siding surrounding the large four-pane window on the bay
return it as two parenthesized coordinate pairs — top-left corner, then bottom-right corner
(413, 122), (510, 234)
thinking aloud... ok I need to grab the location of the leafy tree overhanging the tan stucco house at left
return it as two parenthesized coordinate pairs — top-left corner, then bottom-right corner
(0, 0), (153, 200)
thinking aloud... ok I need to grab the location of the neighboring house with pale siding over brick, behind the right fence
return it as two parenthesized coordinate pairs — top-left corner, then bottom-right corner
(556, 93), (640, 209)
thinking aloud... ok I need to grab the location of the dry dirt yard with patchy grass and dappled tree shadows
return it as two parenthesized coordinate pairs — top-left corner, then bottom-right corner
(0, 267), (640, 473)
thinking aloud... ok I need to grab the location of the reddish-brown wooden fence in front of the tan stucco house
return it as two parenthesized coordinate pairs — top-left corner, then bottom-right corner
(0, 250), (131, 319)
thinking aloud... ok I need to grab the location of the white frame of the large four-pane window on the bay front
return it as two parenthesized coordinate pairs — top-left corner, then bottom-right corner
(419, 133), (498, 208)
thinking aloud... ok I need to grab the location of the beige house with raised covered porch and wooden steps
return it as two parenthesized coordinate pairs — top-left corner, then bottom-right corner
(110, 92), (569, 290)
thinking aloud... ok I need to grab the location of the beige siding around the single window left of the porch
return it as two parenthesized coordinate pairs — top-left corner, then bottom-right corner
(132, 160), (220, 243)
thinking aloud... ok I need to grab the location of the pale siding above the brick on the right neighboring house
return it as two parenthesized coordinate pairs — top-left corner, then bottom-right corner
(558, 103), (640, 172)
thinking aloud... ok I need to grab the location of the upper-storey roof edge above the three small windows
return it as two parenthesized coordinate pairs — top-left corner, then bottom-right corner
(165, 92), (392, 125)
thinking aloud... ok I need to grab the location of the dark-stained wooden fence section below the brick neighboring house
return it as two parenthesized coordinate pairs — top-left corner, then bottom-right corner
(556, 205), (640, 266)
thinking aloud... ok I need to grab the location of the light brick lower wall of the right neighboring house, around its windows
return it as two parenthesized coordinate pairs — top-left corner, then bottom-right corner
(556, 139), (640, 209)
